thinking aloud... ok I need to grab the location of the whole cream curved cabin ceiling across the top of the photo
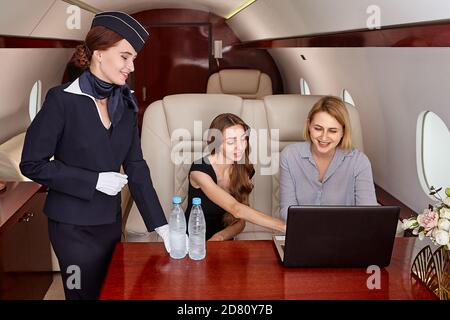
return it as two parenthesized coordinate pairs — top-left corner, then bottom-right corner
(0, 0), (450, 41)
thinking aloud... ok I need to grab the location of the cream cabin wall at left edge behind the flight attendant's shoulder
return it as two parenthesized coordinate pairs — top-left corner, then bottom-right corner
(0, 48), (73, 144)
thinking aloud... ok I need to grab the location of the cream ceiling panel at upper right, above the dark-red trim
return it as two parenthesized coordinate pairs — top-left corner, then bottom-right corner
(232, 0), (450, 41)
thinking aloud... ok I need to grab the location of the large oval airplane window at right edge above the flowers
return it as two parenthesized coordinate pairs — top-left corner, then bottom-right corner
(416, 111), (450, 199)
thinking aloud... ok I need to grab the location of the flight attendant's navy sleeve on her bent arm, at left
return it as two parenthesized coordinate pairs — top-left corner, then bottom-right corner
(20, 89), (98, 200)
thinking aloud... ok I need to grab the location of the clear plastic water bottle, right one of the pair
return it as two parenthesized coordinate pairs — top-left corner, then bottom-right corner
(188, 198), (206, 260)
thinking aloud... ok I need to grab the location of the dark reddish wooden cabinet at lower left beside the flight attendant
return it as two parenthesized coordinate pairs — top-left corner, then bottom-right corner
(0, 182), (52, 300)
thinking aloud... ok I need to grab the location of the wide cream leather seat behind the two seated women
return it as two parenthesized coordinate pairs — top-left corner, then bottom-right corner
(124, 94), (363, 241)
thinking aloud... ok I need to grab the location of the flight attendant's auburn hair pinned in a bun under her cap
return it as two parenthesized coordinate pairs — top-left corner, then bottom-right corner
(70, 26), (123, 69)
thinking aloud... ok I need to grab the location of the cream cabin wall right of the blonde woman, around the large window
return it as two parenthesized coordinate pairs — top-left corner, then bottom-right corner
(269, 48), (450, 211)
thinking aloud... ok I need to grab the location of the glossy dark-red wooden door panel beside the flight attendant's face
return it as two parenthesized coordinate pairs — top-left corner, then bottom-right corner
(134, 23), (211, 127)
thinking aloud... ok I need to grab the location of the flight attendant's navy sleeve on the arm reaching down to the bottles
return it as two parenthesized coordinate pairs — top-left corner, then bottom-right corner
(123, 119), (167, 231)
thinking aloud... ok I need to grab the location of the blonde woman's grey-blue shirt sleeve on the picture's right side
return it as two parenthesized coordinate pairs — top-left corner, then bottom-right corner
(355, 153), (378, 206)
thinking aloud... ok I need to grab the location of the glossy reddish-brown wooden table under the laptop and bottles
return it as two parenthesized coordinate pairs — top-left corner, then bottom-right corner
(100, 238), (436, 300)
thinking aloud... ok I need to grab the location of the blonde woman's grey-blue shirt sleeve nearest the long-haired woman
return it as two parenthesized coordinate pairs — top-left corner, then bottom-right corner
(280, 149), (298, 221)
